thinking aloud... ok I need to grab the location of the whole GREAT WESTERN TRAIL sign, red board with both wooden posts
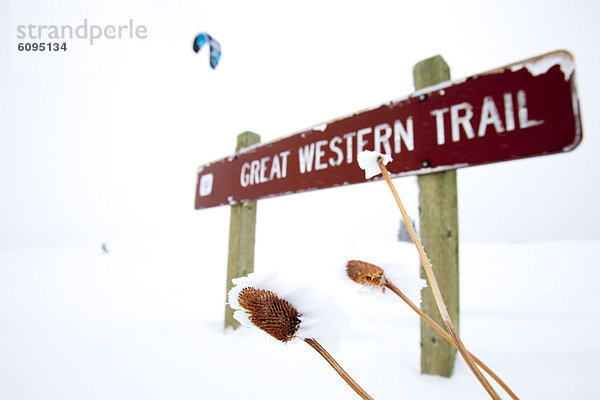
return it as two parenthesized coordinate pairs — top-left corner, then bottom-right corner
(195, 51), (582, 376)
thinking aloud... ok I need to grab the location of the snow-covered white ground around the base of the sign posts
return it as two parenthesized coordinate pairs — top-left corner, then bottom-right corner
(0, 236), (600, 400)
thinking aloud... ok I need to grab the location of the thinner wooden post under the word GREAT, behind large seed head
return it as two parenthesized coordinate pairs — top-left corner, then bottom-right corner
(225, 132), (260, 328)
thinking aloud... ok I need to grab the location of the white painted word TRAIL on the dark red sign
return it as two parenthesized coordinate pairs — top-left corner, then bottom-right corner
(432, 90), (544, 145)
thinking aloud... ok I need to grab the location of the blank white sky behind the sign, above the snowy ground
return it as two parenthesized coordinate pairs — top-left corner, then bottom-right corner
(0, 0), (600, 249)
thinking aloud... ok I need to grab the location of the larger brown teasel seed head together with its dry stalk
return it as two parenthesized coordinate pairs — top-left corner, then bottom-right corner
(238, 287), (373, 400)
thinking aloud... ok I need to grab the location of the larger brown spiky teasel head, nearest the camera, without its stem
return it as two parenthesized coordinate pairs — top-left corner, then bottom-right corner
(238, 287), (300, 342)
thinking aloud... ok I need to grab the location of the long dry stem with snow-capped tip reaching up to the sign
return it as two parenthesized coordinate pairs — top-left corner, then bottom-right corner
(377, 157), (501, 400)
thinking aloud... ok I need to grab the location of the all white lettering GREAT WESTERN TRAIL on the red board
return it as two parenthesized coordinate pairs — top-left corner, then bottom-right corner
(240, 90), (544, 187)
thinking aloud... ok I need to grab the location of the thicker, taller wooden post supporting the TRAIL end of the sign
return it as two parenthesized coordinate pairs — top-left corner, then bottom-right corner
(413, 56), (459, 377)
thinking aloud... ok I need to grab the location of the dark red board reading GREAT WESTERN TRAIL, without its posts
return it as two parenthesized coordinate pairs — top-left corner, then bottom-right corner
(196, 51), (582, 209)
